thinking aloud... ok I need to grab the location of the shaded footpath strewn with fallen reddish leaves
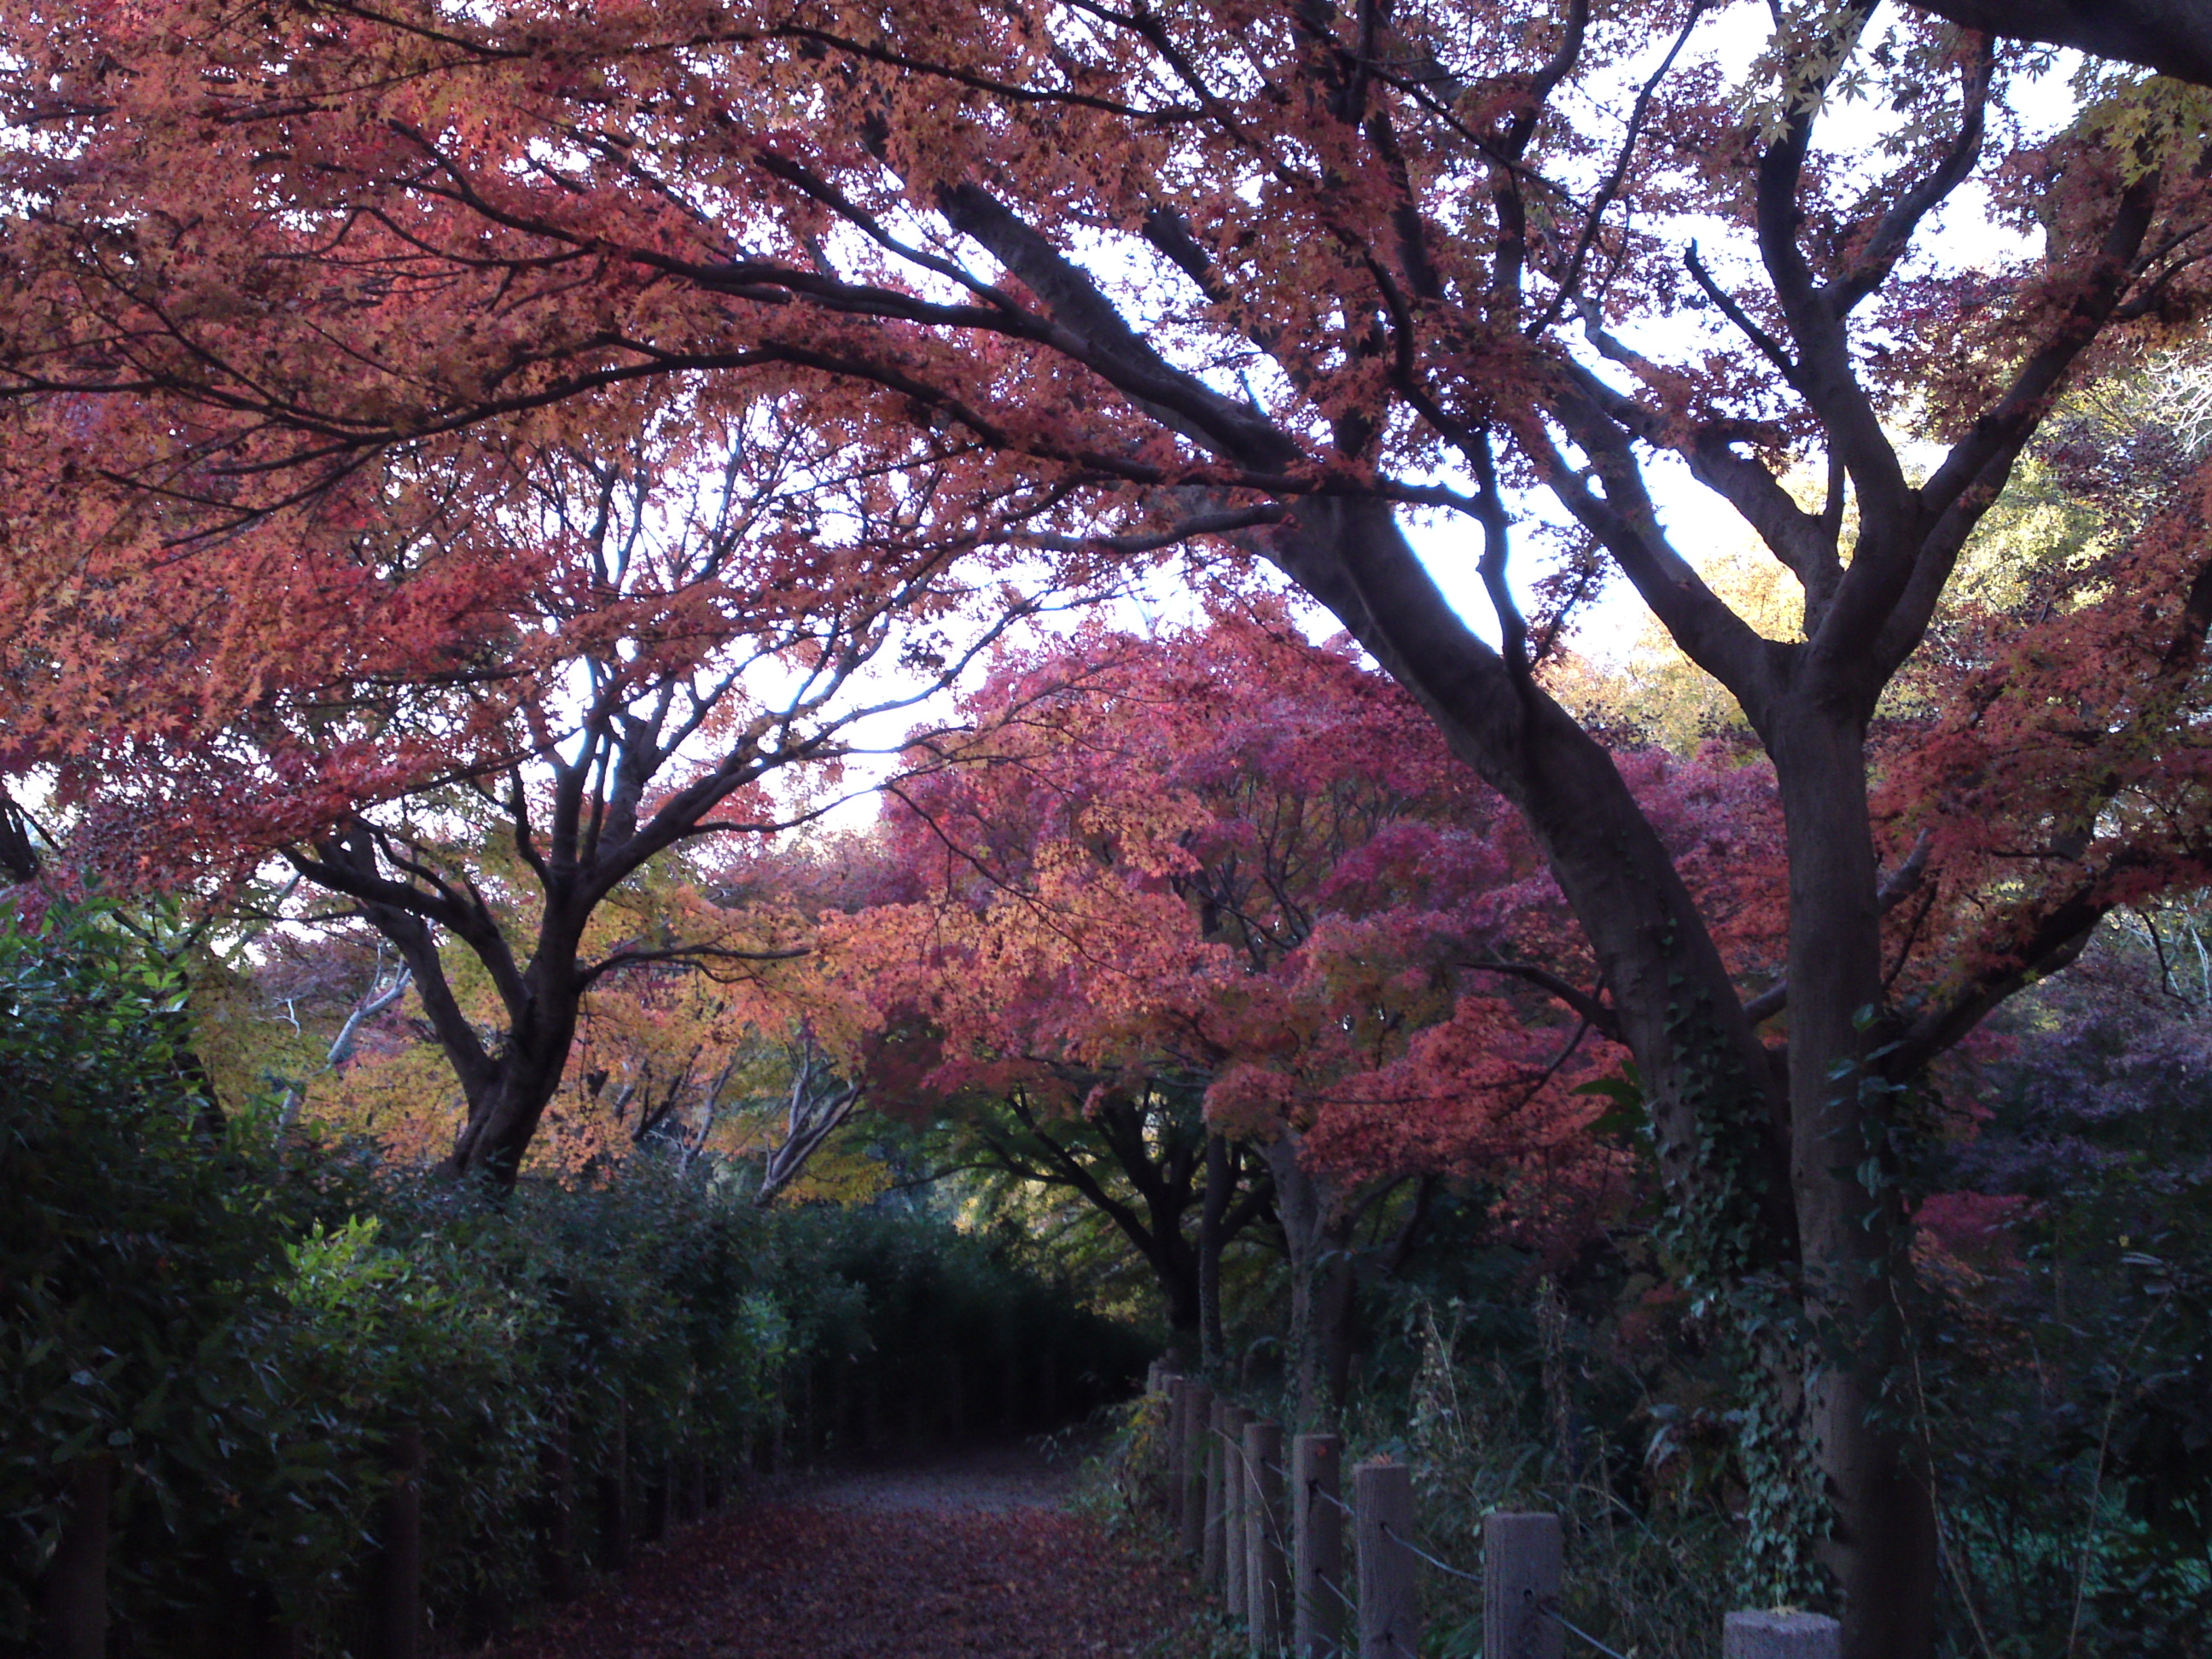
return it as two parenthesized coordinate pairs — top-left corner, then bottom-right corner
(485, 1445), (1212, 1659)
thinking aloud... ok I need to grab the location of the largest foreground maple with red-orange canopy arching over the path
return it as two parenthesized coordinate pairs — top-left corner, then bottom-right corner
(13, 0), (2205, 1659)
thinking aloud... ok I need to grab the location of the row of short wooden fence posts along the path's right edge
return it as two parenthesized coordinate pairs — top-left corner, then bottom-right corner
(1146, 1363), (1841, 1659)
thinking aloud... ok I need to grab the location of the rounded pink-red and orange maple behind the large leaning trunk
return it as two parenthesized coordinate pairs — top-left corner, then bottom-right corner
(836, 602), (1690, 1416)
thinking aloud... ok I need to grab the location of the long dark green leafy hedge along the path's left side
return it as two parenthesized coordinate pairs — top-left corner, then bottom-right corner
(0, 907), (1144, 1659)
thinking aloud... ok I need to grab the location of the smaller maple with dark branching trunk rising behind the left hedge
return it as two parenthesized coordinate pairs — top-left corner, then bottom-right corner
(55, 414), (1066, 1185)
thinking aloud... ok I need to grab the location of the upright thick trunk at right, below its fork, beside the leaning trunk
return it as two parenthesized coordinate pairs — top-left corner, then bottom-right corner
(1770, 707), (1936, 1659)
